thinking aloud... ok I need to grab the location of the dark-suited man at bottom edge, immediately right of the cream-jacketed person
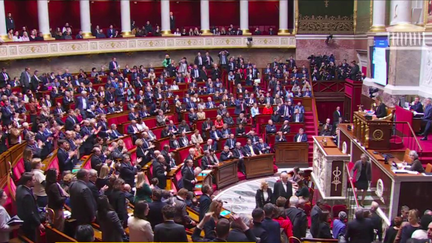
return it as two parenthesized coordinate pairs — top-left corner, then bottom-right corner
(154, 205), (188, 242)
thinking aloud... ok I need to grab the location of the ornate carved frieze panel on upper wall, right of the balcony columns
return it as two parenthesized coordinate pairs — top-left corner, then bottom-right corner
(299, 15), (354, 34)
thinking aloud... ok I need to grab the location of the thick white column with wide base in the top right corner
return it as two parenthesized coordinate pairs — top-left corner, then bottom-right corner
(386, 0), (424, 32)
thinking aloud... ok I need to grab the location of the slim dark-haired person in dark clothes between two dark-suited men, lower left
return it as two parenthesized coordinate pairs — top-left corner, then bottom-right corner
(45, 169), (69, 231)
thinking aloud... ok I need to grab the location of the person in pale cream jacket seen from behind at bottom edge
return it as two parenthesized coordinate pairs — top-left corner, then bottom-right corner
(128, 200), (153, 242)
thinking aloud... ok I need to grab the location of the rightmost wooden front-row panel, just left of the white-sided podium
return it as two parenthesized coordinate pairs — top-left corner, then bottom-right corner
(275, 142), (309, 167)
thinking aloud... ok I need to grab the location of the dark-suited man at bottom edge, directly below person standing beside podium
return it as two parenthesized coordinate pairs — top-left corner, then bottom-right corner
(345, 207), (374, 243)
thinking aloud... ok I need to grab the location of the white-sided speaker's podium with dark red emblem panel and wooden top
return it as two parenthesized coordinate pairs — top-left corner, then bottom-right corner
(312, 136), (350, 198)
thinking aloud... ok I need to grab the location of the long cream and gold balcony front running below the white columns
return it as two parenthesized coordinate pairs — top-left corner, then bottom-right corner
(0, 36), (296, 61)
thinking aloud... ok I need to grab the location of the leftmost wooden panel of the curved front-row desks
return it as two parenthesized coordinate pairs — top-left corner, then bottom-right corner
(213, 160), (238, 190)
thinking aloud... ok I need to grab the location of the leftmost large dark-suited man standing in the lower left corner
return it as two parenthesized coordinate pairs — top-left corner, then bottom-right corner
(16, 172), (45, 242)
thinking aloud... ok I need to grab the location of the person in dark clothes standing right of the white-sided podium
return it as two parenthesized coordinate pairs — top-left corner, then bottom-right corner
(349, 154), (372, 207)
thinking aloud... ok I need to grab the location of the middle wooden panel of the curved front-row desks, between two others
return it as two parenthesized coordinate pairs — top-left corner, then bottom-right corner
(243, 153), (274, 179)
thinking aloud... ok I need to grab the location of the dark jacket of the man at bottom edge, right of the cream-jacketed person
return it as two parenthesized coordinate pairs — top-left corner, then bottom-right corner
(153, 221), (188, 242)
